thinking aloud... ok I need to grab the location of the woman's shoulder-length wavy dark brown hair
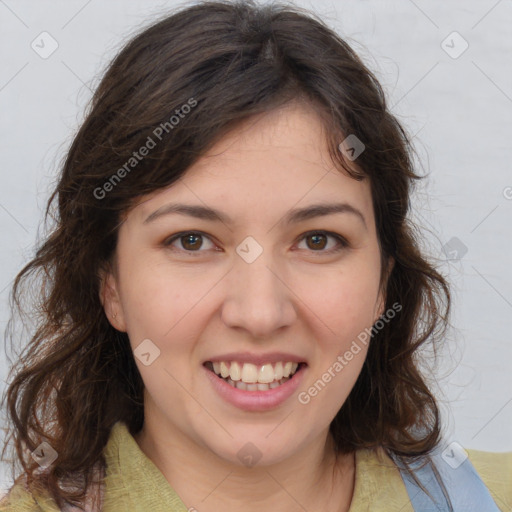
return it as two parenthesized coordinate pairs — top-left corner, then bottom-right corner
(4, 1), (450, 506)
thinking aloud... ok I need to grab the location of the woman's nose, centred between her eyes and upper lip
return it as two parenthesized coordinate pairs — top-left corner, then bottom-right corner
(222, 251), (296, 338)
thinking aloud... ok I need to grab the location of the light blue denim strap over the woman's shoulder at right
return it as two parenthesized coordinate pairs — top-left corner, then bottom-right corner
(395, 443), (500, 512)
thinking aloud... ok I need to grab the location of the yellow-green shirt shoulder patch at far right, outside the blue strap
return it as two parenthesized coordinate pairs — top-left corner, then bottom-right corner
(466, 449), (512, 510)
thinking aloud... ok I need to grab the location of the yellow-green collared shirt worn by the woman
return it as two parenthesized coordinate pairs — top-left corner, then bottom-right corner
(0, 423), (512, 512)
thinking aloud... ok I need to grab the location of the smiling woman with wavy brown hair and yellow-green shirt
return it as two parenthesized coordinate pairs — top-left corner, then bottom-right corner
(1, 2), (512, 512)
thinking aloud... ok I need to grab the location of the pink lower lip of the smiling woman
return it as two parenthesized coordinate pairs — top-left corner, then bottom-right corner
(203, 366), (307, 411)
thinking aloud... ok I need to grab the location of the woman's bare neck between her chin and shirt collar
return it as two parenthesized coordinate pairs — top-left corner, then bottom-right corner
(135, 414), (355, 512)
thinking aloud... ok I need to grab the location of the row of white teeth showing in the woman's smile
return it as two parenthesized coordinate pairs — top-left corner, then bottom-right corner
(213, 361), (299, 384)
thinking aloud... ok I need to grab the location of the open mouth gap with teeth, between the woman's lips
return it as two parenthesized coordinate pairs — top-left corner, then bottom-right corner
(204, 361), (307, 391)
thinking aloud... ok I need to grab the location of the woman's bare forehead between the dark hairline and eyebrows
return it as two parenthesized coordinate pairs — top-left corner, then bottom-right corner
(133, 102), (373, 226)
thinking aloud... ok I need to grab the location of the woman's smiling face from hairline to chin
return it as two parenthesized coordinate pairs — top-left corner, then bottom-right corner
(104, 103), (383, 464)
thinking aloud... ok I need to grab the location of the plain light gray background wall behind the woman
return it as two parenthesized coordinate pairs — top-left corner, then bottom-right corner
(0, 0), (512, 489)
